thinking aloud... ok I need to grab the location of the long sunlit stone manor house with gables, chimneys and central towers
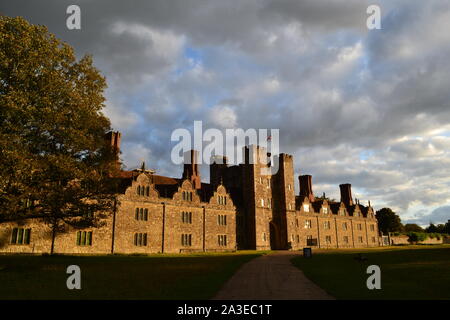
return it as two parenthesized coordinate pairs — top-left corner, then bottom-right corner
(0, 132), (380, 254)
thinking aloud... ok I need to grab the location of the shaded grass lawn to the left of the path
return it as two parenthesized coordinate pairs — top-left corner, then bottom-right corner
(0, 251), (265, 300)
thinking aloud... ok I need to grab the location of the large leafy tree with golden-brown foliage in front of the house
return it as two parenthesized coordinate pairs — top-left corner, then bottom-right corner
(0, 16), (117, 252)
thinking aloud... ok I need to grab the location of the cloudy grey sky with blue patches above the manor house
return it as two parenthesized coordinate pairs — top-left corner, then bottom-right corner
(0, 0), (450, 225)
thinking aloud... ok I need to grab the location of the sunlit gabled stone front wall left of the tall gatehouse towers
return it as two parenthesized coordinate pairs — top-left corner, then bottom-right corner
(0, 174), (236, 254)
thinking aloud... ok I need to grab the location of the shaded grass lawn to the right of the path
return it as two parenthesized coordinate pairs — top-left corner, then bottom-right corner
(292, 245), (450, 300)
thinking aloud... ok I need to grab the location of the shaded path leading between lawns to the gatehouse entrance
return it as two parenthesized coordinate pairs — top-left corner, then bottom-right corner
(213, 251), (334, 300)
